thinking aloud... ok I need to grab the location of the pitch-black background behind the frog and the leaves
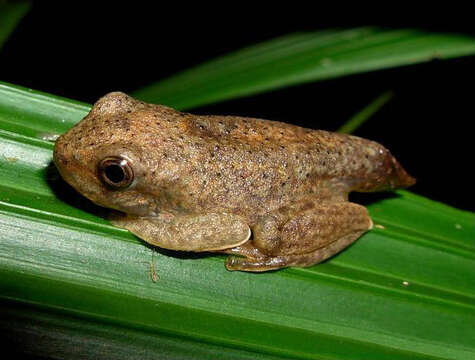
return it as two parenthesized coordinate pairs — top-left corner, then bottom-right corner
(0, 2), (475, 211)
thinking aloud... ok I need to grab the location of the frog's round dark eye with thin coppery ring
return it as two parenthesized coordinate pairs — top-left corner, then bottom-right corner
(98, 156), (134, 189)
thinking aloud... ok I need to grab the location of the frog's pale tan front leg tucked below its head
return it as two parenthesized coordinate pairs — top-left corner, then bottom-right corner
(110, 214), (251, 251)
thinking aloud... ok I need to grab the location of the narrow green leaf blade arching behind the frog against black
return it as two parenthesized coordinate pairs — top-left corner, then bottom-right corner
(133, 27), (475, 109)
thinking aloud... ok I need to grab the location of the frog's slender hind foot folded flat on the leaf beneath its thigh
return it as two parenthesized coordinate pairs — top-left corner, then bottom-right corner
(226, 233), (361, 272)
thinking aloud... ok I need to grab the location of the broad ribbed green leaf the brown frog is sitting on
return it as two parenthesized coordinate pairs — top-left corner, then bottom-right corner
(0, 84), (475, 360)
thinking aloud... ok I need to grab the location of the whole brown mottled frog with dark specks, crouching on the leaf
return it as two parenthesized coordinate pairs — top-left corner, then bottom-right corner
(54, 92), (414, 271)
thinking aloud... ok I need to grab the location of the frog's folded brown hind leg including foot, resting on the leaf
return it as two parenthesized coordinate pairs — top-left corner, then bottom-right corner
(226, 201), (372, 272)
